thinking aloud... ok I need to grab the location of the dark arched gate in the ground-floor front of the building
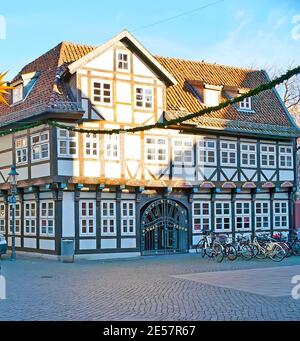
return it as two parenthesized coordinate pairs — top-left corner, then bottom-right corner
(141, 199), (188, 255)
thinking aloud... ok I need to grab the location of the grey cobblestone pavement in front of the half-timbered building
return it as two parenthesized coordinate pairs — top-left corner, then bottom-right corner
(0, 254), (300, 321)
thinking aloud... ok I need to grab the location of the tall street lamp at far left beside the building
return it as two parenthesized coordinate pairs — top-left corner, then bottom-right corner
(7, 166), (19, 261)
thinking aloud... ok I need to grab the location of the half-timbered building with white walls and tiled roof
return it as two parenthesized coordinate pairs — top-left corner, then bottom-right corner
(0, 31), (298, 257)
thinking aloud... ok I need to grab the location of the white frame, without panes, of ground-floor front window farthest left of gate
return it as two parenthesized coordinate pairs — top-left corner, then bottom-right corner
(79, 199), (97, 237)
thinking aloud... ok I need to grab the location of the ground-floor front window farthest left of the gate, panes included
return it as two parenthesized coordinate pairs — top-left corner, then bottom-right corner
(79, 200), (96, 237)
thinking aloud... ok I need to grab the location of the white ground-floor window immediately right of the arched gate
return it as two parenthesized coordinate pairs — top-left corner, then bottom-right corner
(193, 201), (211, 233)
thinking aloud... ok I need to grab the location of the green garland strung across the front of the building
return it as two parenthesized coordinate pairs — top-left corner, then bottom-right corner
(0, 66), (300, 136)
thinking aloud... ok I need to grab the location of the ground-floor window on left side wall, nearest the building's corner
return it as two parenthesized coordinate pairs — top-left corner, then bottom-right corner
(40, 200), (55, 237)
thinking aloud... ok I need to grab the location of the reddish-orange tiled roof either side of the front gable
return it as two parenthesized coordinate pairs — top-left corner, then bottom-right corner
(0, 42), (294, 137)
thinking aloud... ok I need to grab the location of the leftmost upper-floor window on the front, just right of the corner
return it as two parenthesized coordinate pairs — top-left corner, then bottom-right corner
(58, 129), (78, 158)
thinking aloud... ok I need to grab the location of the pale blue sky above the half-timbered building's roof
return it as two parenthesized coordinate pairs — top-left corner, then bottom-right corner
(0, 0), (300, 78)
